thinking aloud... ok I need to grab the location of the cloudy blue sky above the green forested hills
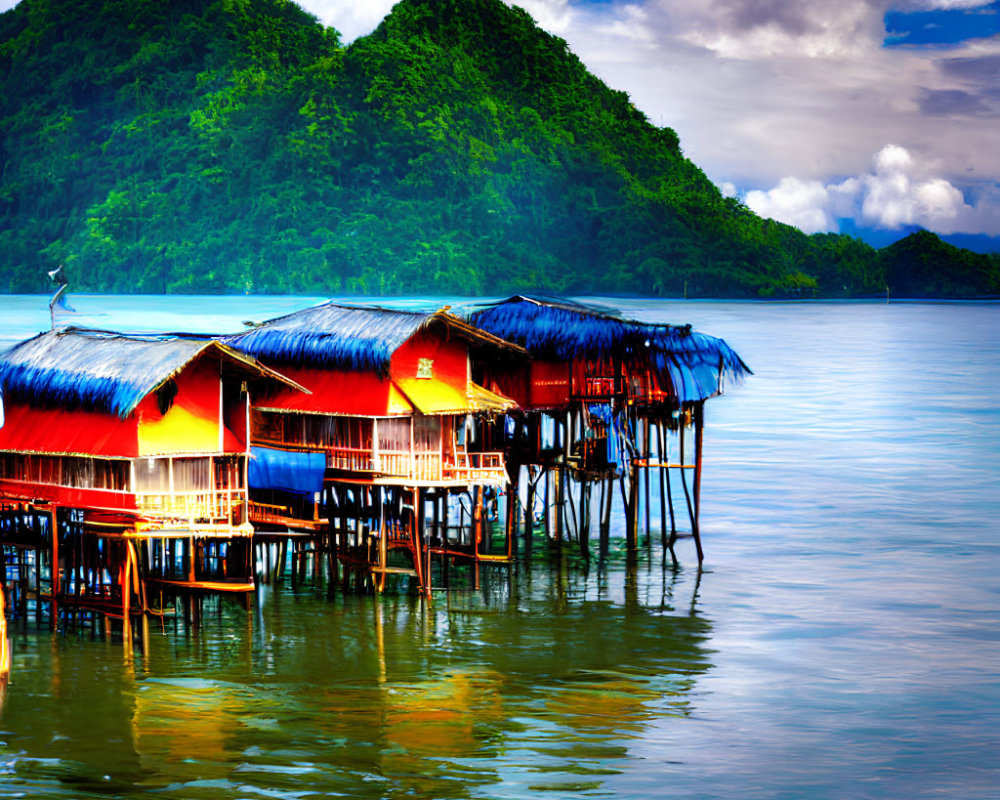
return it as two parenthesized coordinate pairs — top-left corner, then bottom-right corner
(0, 0), (1000, 249)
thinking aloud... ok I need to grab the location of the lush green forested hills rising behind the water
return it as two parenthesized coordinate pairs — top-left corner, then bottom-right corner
(0, 0), (1000, 297)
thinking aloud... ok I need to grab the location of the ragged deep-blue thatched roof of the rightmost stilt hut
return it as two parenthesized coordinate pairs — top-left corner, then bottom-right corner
(466, 295), (751, 403)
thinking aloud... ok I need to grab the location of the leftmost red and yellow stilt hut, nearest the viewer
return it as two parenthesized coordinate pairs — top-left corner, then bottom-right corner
(0, 328), (301, 614)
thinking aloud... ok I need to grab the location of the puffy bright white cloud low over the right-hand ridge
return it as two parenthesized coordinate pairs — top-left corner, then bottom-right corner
(744, 144), (1000, 235)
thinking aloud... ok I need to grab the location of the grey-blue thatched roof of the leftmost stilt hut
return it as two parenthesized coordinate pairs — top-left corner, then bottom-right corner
(0, 328), (304, 418)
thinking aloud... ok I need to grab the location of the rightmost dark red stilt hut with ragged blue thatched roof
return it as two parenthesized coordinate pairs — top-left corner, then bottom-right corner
(466, 296), (750, 561)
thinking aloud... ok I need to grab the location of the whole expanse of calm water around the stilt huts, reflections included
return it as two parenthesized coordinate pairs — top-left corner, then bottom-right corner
(0, 297), (1000, 800)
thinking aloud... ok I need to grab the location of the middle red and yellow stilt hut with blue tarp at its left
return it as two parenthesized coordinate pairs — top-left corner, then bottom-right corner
(224, 302), (524, 589)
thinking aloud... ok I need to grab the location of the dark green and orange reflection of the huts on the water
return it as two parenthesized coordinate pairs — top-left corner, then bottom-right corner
(0, 565), (711, 800)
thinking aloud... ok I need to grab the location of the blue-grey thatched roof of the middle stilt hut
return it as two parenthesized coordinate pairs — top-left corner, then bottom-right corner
(220, 302), (520, 375)
